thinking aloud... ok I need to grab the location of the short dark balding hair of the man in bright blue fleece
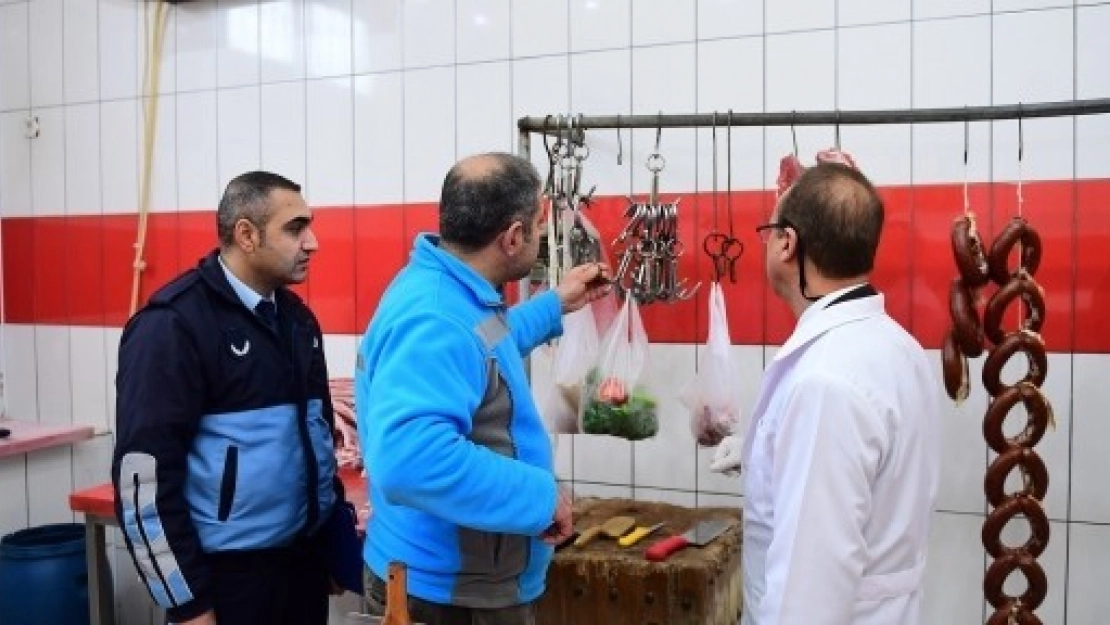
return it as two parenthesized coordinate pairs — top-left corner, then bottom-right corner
(440, 152), (539, 251)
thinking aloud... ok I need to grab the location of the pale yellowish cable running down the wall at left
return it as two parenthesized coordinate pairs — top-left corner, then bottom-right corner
(128, 0), (168, 316)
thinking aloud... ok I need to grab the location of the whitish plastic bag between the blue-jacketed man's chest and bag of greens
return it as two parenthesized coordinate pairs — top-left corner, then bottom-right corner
(543, 306), (598, 434)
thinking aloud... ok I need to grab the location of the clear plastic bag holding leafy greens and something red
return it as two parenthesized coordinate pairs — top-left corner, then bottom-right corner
(581, 298), (659, 441)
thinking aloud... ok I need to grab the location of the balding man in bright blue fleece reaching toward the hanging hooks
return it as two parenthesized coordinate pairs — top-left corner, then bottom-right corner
(355, 153), (609, 625)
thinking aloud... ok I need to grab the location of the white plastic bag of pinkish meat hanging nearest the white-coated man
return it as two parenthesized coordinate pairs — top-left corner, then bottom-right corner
(683, 282), (740, 447)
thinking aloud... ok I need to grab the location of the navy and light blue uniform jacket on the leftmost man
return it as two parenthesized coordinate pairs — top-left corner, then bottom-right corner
(112, 251), (342, 621)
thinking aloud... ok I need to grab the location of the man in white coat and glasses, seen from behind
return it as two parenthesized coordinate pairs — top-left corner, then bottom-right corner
(741, 163), (940, 625)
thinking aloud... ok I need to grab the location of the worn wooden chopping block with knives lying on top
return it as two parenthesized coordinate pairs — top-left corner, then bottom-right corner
(536, 497), (743, 625)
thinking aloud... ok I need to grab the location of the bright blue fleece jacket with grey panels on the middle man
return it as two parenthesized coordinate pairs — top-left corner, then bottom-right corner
(355, 234), (563, 608)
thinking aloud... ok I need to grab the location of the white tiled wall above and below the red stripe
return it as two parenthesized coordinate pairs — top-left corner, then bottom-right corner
(0, 0), (1110, 625)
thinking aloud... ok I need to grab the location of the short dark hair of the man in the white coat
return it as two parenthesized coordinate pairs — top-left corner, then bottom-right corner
(778, 163), (884, 279)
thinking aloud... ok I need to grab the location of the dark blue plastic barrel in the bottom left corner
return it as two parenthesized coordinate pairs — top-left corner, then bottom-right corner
(0, 523), (89, 625)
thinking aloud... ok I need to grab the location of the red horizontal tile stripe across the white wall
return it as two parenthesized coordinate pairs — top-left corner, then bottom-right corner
(0, 180), (1110, 353)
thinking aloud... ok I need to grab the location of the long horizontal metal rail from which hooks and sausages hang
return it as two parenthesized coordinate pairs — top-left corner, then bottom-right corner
(516, 98), (1110, 133)
